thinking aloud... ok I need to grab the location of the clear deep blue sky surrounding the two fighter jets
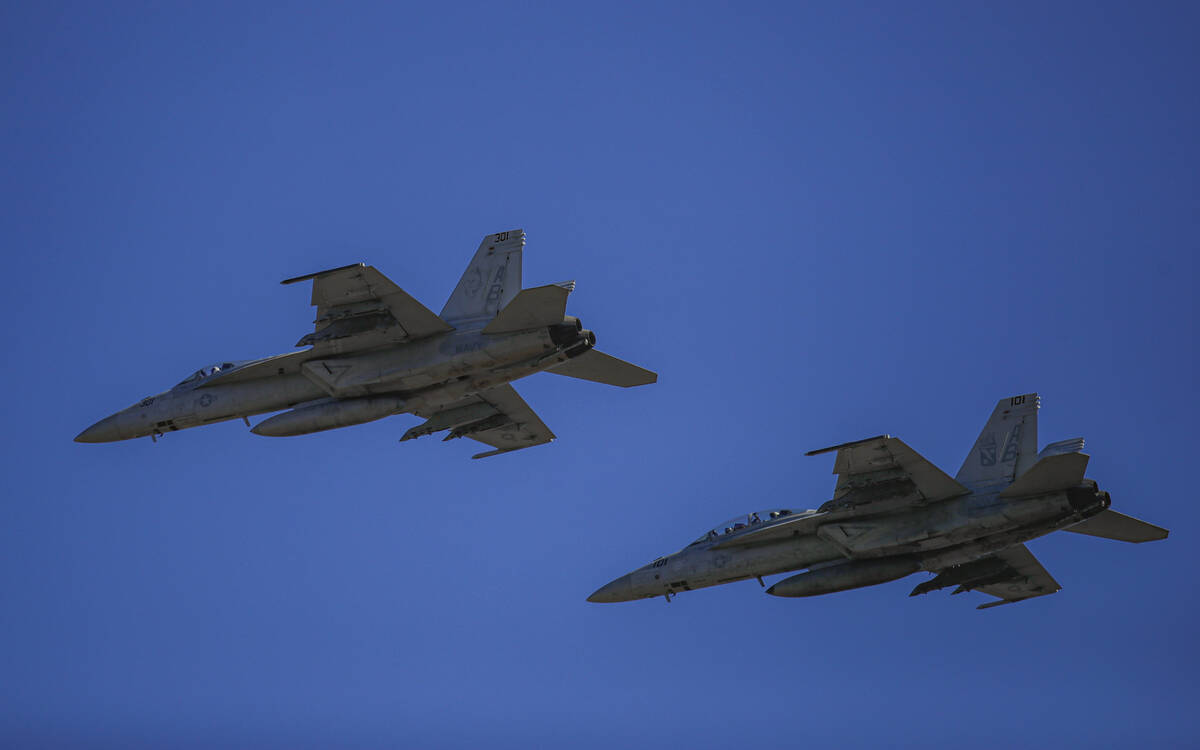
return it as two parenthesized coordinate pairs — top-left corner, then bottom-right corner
(0, 2), (1200, 748)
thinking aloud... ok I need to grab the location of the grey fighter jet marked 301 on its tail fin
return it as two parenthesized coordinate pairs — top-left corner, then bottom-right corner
(76, 229), (658, 458)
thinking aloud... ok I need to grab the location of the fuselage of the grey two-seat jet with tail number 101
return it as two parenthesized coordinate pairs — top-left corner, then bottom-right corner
(588, 480), (1109, 602)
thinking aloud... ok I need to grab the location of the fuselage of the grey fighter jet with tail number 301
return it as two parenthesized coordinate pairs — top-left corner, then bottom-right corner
(76, 319), (595, 443)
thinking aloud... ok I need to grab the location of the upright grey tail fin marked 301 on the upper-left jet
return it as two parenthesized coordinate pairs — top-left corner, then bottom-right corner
(440, 229), (524, 323)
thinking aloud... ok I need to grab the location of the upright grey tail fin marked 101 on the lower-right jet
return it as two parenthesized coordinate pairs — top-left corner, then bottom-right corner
(954, 394), (1042, 490)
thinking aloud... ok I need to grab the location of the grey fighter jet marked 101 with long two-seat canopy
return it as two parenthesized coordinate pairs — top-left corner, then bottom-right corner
(588, 394), (1168, 610)
